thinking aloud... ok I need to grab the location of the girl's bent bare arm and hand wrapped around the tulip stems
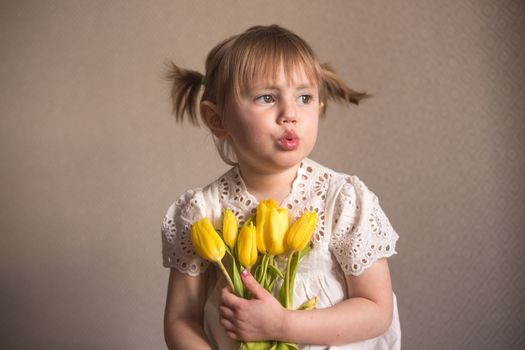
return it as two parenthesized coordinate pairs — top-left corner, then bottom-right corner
(220, 259), (393, 345)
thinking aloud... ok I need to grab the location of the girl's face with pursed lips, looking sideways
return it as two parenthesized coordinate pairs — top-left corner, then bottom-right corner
(224, 67), (321, 173)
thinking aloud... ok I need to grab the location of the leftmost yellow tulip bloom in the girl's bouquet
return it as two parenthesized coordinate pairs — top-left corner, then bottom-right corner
(191, 218), (226, 262)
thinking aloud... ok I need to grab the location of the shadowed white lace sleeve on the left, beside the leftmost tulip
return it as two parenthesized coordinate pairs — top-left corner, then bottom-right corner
(162, 190), (209, 276)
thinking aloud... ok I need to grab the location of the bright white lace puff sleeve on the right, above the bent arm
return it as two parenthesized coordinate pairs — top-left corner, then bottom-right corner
(330, 176), (399, 276)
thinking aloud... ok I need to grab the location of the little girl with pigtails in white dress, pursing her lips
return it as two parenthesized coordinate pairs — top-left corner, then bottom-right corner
(162, 25), (401, 350)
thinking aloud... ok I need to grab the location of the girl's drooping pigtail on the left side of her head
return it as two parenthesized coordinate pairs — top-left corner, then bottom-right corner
(166, 62), (204, 125)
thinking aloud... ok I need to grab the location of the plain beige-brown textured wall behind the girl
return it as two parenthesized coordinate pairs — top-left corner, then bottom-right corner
(0, 0), (525, 349)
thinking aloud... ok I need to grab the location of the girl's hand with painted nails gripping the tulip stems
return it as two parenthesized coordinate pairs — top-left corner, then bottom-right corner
(219, 270), (286, 341)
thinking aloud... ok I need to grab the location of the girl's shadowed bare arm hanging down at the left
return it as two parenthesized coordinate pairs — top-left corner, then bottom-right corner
(164, 268), (211, 350)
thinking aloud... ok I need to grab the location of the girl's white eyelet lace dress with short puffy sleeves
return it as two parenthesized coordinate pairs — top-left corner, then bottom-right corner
(162, 159), (401, 350)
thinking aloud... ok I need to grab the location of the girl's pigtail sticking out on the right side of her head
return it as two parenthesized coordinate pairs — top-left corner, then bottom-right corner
(321, 63), (371, 105)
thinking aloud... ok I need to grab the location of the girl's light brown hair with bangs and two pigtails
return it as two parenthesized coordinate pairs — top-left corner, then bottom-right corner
(168, 25), (369, 165)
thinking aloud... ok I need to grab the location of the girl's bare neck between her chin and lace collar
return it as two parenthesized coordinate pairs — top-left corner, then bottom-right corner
(239, 163), (301, 204)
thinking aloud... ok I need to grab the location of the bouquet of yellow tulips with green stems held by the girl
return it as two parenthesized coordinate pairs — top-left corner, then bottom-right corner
(191, 199), (317, 350)
